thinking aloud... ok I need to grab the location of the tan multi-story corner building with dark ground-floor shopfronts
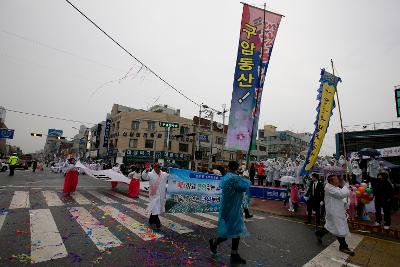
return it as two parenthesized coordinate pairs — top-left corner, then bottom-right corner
(109, 104), (194, 168)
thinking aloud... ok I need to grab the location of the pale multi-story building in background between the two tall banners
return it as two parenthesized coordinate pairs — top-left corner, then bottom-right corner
(258, 125), (312, 159)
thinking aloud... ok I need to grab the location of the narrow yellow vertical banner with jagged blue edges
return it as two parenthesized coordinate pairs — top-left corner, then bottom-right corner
(301, 69), (342, 176)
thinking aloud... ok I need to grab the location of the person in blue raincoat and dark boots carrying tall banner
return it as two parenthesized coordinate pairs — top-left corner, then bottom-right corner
(209, 161), (250, 264)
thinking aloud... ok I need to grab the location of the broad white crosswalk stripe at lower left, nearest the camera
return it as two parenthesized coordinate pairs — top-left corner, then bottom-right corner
(29, 209), (68, 263)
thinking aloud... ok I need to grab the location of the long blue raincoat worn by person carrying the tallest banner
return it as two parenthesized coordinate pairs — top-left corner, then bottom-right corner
(217, 172), (250, 238)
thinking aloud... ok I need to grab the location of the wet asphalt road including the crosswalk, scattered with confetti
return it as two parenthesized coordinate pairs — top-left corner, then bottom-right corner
(0, 170), (396, 266)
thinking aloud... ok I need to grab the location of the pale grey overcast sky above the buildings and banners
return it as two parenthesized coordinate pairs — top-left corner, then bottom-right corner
(0, 0), (400, 154)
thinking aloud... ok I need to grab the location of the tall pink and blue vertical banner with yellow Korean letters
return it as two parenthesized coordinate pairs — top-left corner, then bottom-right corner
(226, 4), (282, 151)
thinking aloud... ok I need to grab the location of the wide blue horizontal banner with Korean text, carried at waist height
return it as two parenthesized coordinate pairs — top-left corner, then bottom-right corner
(165, 168), (222, 213)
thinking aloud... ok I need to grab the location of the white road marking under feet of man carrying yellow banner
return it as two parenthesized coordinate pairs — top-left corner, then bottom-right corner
(303, 234), (363, 267)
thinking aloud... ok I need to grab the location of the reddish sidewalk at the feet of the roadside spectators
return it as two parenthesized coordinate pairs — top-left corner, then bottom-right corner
(251, 198), (400, 240)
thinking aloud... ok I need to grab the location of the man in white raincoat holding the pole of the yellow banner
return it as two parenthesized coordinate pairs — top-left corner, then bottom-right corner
(315, 175), (355, 256)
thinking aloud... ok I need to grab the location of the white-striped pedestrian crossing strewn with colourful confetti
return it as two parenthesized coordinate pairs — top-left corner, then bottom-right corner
(0, 190), (268, 263)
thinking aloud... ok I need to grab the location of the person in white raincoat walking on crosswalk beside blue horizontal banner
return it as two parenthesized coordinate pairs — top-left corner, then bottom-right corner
(147, 163), (169, 229)
